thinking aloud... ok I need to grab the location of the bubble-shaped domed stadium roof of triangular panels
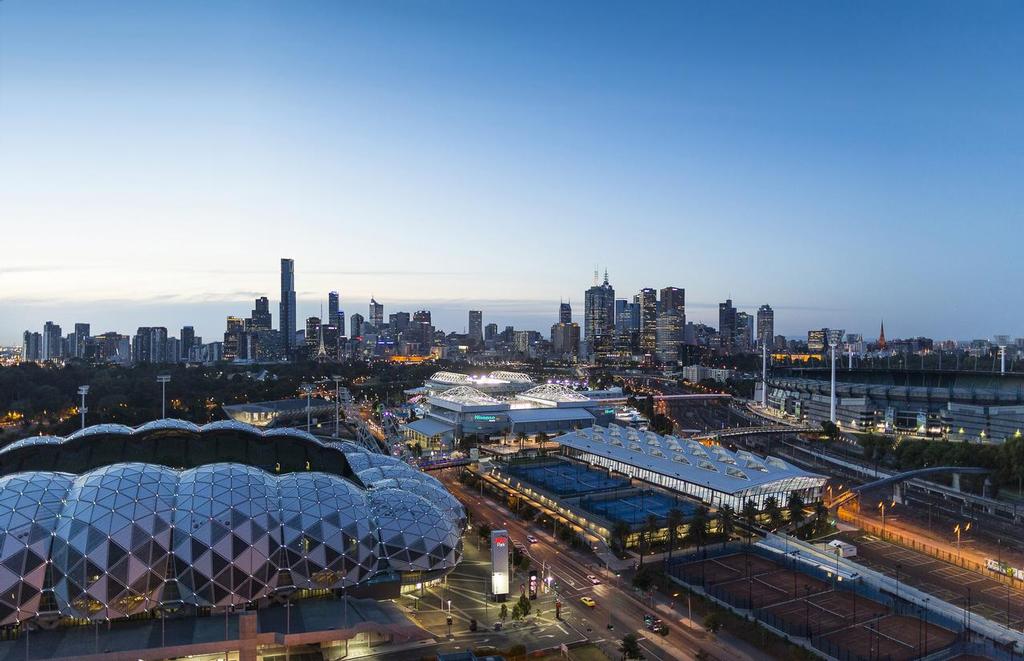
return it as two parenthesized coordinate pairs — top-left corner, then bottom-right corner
(0, 421), (465, 625)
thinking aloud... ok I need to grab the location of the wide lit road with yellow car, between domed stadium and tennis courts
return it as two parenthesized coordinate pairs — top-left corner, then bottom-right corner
(441, 472), (757, 661)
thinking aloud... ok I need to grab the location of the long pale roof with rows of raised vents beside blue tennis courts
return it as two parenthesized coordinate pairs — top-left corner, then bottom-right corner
(555, 425), (825, 493)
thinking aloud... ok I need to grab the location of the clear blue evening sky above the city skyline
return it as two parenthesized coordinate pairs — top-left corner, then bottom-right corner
(0, 0), (1024, 343)
